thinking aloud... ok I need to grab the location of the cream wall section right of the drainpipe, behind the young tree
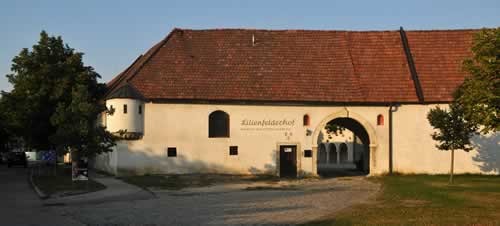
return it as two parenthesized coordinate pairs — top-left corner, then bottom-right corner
(393, 105), (500, 174)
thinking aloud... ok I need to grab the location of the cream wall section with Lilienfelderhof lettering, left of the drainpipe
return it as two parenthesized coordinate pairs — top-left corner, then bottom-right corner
(99, 102), (387, 174)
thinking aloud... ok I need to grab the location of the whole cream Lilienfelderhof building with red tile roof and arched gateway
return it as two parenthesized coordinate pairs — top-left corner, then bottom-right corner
(95, 29), (500, 176)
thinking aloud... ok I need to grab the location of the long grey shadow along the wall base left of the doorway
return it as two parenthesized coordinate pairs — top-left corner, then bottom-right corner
(94, 145), (276, 176)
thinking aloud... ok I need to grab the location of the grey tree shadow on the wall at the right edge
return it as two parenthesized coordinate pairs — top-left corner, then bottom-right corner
(472, 132), (500, 174)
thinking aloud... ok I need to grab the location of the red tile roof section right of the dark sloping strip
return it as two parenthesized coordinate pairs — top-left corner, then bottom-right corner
(406, 30), (477, 102)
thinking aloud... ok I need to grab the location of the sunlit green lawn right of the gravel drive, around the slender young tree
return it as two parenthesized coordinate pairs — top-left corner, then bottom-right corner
(306, 175), (500, 225)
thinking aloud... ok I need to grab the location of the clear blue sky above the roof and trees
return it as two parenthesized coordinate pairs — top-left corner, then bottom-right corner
(0, 0), (500, 91)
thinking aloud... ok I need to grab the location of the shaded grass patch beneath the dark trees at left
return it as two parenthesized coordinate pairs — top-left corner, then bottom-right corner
(33, 166), (106, 196)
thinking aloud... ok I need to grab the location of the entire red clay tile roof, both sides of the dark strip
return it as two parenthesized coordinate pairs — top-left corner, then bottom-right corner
(108, 29), (476, 103)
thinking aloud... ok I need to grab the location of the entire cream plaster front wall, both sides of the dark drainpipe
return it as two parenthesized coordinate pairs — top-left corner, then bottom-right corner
(95, 102), (500, 175)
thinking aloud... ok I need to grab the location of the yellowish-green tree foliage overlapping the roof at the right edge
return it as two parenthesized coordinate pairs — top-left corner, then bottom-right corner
(454, 28), (500, 133)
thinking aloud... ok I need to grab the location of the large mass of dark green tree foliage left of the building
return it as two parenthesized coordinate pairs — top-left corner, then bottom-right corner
(3, 31), (114, 154)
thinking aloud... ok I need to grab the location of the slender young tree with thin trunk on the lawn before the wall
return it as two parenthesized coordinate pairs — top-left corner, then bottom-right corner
(427, 103), (477, 184)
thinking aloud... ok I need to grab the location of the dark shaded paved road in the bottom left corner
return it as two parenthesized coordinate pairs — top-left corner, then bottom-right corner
(0, 165), (82, 226)
